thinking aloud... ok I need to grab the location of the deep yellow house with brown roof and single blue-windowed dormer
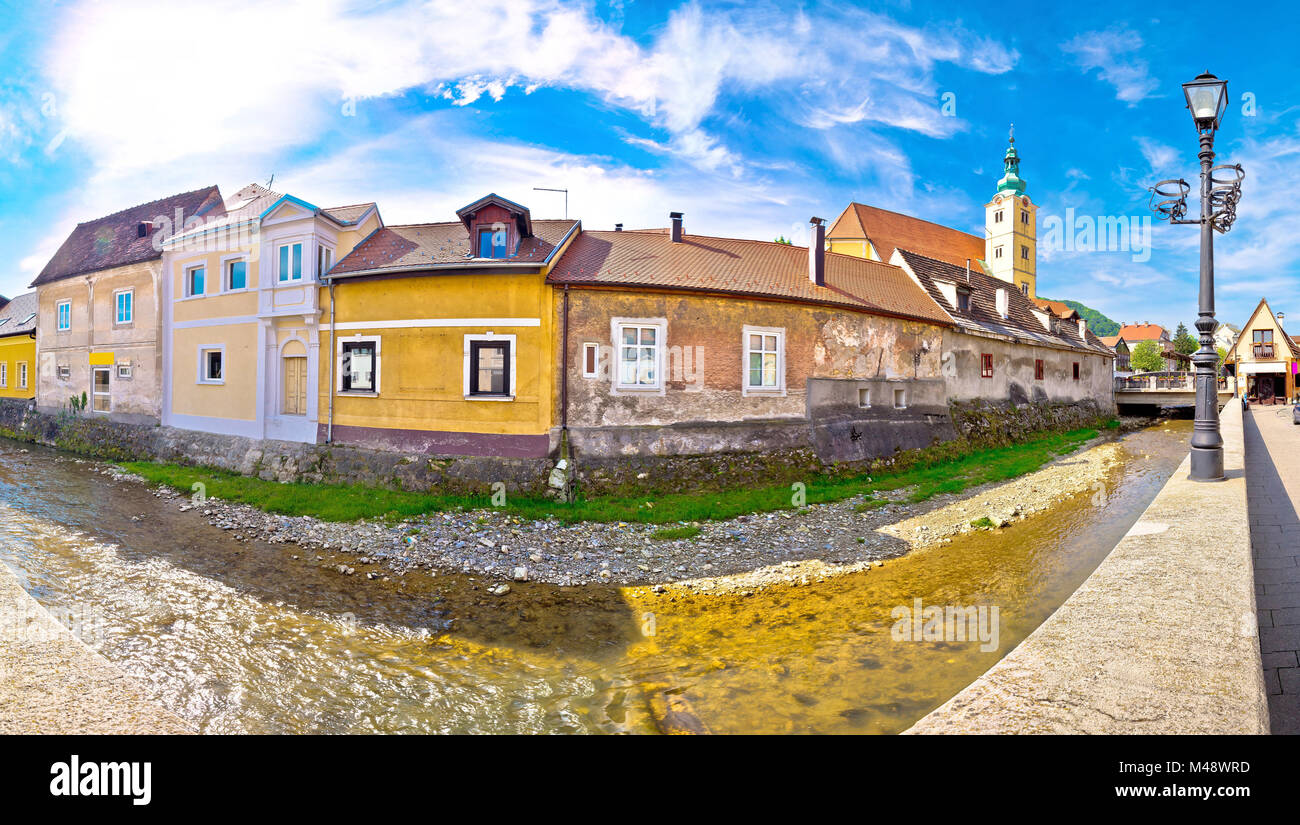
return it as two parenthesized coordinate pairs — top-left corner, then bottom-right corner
(312, 195), (580, 457)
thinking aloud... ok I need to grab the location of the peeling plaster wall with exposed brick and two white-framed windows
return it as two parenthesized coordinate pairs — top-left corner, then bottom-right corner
(559, 290), (943, 460)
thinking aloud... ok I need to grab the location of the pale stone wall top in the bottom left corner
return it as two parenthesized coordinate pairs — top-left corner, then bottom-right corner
(0, 564), (194, 734)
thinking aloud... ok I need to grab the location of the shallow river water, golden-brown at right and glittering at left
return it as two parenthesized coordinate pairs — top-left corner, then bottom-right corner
(0, 421), (1191, 733)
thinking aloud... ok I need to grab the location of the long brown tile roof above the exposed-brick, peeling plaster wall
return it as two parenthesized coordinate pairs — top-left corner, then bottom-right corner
(547, 230), (952, 326)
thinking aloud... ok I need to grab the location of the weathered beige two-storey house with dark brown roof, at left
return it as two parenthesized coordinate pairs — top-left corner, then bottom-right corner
(31, 186), (222, 424)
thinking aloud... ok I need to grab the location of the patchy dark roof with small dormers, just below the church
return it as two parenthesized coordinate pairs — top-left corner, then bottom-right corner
(900, 249), (1113, 355)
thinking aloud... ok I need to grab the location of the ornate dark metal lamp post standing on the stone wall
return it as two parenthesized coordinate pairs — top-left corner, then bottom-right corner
(1151, 71), (1245, 481)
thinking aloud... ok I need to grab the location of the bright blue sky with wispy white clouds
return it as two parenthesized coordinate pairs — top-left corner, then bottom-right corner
(0, 0), (1300, 331)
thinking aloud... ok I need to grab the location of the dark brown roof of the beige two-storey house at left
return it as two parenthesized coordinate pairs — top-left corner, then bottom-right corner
(31, 186), (225, 286)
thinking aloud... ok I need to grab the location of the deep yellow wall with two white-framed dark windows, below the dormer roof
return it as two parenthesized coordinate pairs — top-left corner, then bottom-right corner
(320, 273), (555, 435)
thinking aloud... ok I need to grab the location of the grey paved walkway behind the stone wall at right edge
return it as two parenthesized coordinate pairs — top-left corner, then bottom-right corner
(1244, 407), (1300, 734)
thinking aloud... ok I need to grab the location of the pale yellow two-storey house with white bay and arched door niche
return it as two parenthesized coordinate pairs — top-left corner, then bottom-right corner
(163, 184), (384, 443)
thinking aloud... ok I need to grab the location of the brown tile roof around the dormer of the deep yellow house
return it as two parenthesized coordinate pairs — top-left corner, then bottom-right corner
(329, 221), (577, 275)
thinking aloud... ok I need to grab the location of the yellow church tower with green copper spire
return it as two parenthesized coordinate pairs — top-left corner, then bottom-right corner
(984, 126), (1039, 298)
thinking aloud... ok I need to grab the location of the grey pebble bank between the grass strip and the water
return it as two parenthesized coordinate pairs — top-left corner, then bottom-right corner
(103, 442), (1121, 595)
